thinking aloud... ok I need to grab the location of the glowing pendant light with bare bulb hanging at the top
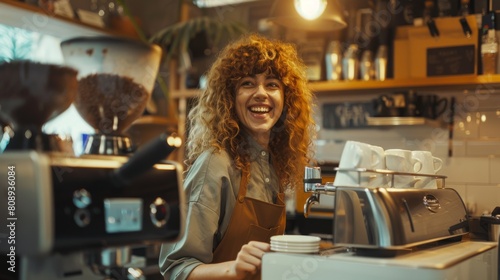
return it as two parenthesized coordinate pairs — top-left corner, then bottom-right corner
(269, 0), (347, 32)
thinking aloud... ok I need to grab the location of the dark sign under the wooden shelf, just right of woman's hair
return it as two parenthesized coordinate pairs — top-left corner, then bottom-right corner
(322, 102), (375, 129)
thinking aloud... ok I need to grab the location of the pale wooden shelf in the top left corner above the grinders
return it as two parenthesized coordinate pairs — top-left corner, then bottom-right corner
(0, 0), (134, 40)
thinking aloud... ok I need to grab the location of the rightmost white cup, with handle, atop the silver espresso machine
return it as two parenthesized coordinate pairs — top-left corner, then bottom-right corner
(412, 151), (443, 189)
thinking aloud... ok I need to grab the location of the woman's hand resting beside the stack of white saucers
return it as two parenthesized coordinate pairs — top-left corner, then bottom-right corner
(231, 241), (270, 279)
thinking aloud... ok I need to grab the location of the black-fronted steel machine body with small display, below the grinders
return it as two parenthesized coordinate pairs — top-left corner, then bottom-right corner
(0, 150), (184, 280)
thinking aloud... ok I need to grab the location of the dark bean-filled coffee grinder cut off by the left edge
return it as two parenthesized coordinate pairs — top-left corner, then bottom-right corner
(0, 60), (77, 152)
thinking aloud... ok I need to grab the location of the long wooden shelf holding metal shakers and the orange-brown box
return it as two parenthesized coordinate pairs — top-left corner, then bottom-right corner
(309, 75), (500, 94)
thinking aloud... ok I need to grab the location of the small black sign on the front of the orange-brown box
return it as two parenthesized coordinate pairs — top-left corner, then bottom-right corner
(427, 45), (476, 77)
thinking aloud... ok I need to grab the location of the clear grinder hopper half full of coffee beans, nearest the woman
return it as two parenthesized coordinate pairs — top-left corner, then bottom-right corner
(61, 37), (162, 155)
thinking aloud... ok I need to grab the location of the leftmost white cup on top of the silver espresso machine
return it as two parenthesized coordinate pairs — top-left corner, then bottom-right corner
(334, 141), (385, 187)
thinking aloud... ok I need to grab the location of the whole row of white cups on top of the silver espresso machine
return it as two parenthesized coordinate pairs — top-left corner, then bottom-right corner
(334, 141), (443, 189)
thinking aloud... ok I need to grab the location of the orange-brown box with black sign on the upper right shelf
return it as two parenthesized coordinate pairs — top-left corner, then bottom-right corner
(394, 15), (479, 79)
